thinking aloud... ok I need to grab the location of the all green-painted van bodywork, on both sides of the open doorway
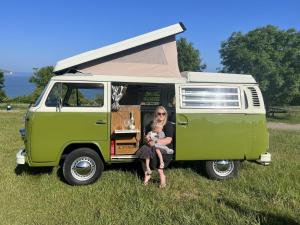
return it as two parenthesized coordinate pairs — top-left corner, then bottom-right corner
(21, 77), (269, 166)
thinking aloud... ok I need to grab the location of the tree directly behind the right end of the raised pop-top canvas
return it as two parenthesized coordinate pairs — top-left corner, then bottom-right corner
(176, 38), (206, 72)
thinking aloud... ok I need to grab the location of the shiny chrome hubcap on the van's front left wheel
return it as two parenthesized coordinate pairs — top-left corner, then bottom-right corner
(71, 156), (96, 181)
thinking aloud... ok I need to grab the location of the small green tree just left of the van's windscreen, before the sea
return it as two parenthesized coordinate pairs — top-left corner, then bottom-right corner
(29, 66), (55, 101)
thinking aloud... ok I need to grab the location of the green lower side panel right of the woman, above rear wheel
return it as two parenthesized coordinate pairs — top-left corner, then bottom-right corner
(176, 114), (268, 160)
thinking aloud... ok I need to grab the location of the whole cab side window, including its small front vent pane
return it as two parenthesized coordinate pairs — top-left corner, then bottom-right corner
(46, 83), (104, 107)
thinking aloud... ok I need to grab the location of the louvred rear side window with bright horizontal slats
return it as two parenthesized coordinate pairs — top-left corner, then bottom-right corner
(180, 86), (241, 109)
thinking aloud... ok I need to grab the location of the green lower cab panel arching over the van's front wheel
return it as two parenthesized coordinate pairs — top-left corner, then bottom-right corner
(25, 112), (110, 166)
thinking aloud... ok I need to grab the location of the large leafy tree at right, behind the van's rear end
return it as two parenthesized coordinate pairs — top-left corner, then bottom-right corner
(220, 25), (300, 107)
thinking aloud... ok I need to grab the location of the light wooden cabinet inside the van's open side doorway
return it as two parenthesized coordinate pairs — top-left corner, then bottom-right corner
(111, 105), (141, 155)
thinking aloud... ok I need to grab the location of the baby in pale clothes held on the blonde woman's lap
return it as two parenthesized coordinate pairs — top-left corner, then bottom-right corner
(146, 123), (174, 175)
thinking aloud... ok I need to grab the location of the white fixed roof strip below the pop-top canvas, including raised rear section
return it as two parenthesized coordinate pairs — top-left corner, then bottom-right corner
(52, 71), (256, 84)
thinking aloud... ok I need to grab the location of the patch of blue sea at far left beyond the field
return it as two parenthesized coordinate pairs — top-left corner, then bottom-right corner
(4, 72), (35, 98)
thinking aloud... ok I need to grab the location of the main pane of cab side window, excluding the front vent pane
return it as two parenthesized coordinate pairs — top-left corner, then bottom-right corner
(63, 83), (104, 107)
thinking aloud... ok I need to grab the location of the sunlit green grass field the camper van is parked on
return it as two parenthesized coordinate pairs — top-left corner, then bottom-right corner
(0, 110), (300, 225)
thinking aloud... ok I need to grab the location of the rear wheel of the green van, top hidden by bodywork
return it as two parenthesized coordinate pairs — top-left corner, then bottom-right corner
(205, 160), (239, 180)
